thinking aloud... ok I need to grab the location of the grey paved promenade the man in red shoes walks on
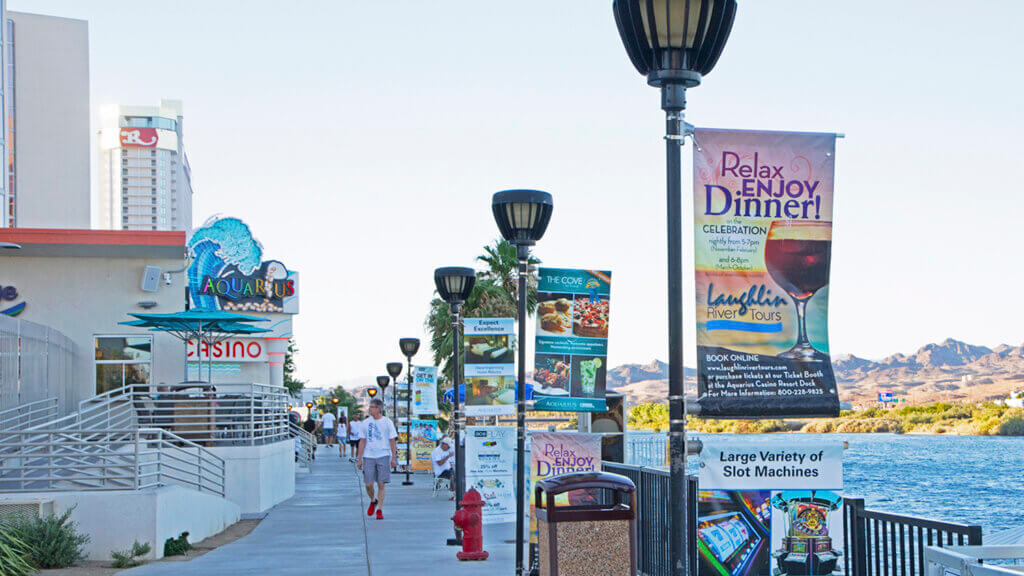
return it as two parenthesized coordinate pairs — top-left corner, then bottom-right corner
(120, 447), (515, 576)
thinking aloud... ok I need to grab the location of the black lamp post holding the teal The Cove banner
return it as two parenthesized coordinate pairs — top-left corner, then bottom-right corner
(490, 190), (554, 576)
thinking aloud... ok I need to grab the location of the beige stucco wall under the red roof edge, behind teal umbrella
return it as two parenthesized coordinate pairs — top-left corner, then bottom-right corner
(0, 252), (185, 411)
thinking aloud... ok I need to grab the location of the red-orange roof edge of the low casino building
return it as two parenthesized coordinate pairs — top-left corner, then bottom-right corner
(0, 228), (185, 260)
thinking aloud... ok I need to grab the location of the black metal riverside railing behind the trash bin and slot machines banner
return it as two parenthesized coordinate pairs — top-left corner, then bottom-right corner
(602, 462), (981, 576)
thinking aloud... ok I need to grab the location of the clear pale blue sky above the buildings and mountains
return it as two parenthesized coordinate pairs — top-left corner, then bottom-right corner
(14, 0), (1024, 385)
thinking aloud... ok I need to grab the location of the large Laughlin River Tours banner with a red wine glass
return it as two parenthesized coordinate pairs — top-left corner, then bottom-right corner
(693, 129), (839, 418)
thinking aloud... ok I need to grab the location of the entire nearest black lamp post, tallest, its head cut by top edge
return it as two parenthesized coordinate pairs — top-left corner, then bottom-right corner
(611, 0), (736, 576)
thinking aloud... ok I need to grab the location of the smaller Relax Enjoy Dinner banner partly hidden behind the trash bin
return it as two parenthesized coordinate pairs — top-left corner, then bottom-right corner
(526, 433), (601, 544)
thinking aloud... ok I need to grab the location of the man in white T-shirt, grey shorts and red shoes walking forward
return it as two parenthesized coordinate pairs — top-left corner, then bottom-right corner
(356, 399), (398, 520)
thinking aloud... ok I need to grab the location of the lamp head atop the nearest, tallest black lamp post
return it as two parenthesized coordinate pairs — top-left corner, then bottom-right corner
(611, 0), (736, 88)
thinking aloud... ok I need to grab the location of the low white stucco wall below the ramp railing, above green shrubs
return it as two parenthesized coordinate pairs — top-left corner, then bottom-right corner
(0, 486), (241, 561)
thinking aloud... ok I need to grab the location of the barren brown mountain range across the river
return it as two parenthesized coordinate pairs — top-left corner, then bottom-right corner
(607, 338), (1024, 404)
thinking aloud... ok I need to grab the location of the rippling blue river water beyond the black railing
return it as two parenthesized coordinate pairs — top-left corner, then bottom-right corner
(630, 431), (1024, 535)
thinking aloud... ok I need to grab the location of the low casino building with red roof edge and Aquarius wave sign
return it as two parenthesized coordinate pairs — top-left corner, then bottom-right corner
(0, 218), (298, 413)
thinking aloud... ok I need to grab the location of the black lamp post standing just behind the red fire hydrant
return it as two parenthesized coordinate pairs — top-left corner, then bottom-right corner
(434, 266), (476, 546)
